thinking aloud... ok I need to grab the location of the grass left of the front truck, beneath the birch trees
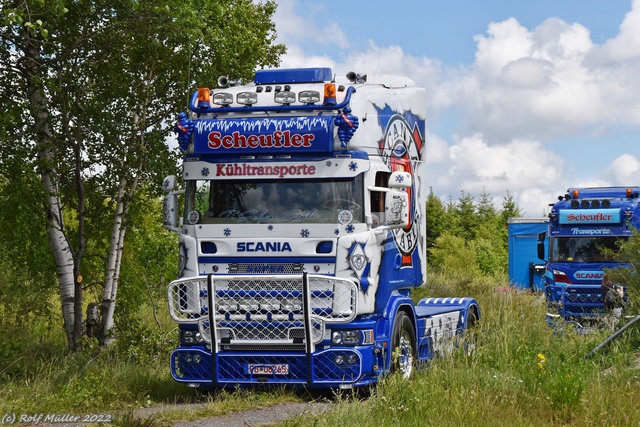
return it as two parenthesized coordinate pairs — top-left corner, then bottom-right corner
(0, 304), (298, 418)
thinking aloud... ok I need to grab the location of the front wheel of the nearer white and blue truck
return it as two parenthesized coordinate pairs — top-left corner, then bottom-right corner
(391, 311), (416, 379)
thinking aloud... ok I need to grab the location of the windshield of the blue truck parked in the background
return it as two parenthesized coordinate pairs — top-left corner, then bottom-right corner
(549, 236), (628, 262)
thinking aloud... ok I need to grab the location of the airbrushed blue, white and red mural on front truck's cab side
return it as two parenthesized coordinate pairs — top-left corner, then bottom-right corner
(337, 106), (426, 313)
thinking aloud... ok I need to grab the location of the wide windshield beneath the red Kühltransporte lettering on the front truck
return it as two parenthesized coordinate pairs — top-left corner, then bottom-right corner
(185, 175), (364, 224)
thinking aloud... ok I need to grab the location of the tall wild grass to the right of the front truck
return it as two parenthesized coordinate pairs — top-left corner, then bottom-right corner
(284, 278), (640, 427)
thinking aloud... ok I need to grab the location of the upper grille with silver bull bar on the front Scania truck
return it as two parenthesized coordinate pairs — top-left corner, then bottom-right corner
(168, 275), (358, 348)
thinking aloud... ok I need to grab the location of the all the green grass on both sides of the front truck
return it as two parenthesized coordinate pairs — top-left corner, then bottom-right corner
(0, 276), (640, 427)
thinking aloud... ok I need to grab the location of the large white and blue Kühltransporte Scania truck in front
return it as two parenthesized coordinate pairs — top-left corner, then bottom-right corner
(163, 68), (480, 388)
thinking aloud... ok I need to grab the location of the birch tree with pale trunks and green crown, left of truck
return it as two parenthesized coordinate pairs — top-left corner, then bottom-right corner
(0, 0), (284, 350)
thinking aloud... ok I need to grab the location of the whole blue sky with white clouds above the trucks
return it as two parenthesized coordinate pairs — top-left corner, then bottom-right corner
(275, 0), (640, 216)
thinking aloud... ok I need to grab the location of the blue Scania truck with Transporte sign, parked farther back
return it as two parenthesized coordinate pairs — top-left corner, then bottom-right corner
(538, 187), (640, 326)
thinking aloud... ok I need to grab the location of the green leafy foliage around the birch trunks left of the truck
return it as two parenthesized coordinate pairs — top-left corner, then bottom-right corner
(0, 0), (285, 349)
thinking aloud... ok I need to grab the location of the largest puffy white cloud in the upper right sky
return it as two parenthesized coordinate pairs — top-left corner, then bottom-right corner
(450, 7), (640, 143)
